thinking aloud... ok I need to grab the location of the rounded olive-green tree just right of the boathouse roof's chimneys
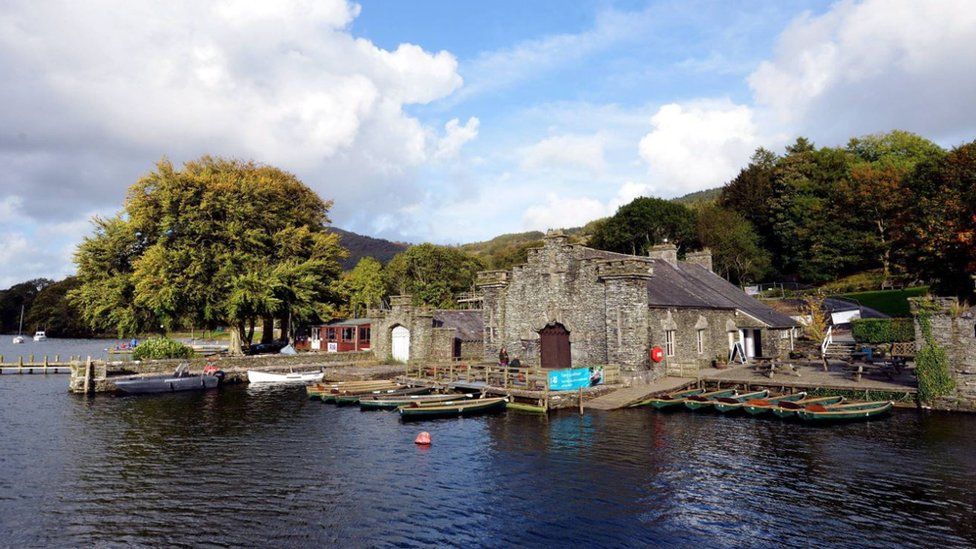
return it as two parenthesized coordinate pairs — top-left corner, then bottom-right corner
(697, 204), (769, 284)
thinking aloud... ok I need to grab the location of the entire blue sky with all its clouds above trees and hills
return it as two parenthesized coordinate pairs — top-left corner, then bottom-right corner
(0, 0), (976, 286)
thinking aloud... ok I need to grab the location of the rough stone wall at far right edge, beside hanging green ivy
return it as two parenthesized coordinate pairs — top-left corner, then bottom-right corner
(909, 297), (976, 412)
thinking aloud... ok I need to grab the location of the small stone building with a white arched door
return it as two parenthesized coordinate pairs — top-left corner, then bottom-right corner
(369, 295), (484, 362)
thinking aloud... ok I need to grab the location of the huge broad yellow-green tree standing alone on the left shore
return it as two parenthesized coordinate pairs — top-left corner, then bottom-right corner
(70, 157), (346, 343)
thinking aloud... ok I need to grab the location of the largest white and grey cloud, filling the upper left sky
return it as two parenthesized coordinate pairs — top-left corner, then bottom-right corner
(0, 0), (471, 216)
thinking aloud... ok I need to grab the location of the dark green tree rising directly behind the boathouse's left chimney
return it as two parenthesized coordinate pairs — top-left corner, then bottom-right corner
(589, 197), (697, 255)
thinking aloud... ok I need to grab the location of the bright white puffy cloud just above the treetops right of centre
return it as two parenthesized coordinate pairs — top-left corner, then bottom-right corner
(639, 101), (761, 197)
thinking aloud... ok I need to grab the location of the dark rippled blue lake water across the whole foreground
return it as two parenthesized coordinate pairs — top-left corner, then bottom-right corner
(0, 375), (976, 547)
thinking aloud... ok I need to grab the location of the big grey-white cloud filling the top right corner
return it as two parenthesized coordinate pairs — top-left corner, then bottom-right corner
(749, 0), (976, 141)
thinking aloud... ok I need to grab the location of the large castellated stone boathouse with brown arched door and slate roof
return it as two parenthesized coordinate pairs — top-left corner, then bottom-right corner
(478, 232), (797, 378)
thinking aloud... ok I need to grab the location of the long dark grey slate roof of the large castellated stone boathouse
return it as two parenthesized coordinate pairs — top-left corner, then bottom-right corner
(647, 259), (797, 328)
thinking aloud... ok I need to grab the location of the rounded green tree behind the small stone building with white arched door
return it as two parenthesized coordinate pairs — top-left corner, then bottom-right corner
(384, 244), (485, 308)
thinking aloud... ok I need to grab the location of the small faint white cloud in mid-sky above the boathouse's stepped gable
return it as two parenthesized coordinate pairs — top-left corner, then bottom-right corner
(521, 134), (607, 172)
